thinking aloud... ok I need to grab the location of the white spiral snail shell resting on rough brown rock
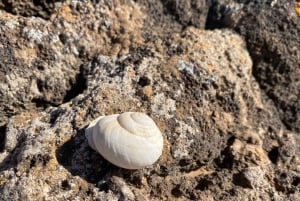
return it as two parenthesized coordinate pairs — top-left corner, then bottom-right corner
(85, 112), (163, 169)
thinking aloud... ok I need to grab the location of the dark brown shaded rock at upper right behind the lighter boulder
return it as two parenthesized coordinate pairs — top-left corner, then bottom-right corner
(206, 0), (300, 135)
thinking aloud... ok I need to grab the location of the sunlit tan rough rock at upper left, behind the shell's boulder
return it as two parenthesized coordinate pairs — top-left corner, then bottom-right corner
(0, 2), (142, 126)
